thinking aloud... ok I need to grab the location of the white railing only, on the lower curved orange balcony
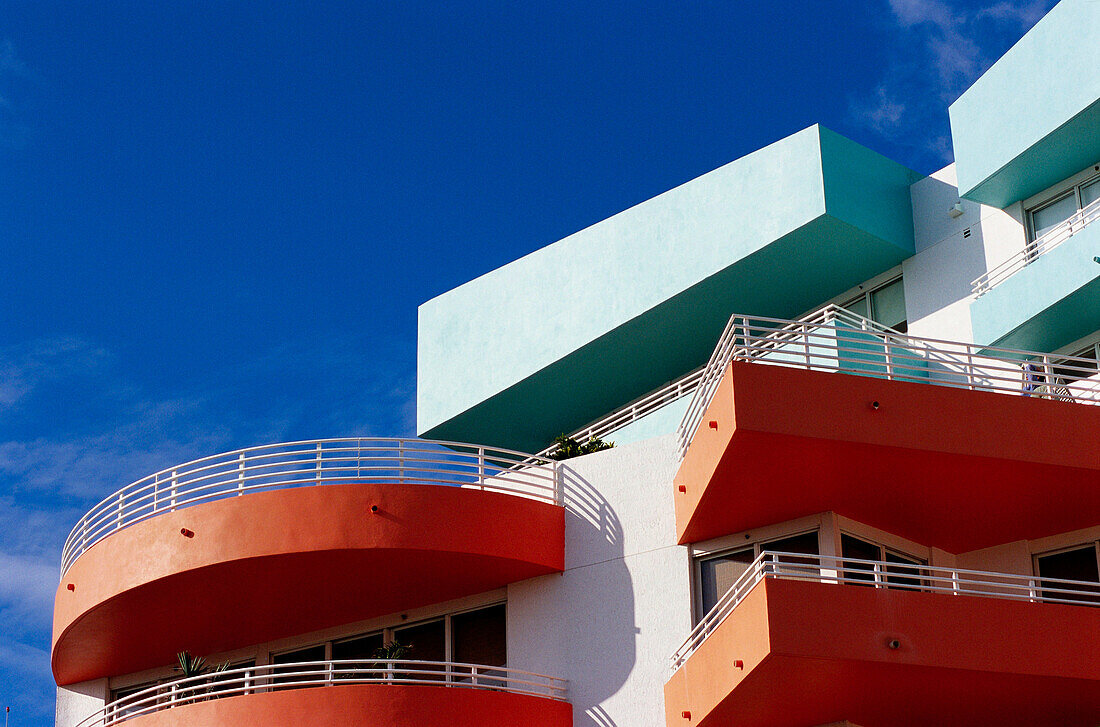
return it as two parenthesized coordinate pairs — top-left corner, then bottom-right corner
(77, 659), (569, 727)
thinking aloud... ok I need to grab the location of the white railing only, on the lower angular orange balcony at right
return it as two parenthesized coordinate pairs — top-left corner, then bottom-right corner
(671, 550), (1100, 672)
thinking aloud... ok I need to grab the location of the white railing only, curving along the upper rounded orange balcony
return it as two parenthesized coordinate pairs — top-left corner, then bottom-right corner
(62, 438), (562, 575)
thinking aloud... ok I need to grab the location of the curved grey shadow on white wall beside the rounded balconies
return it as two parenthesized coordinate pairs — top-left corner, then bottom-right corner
(556, 466), (638, 727)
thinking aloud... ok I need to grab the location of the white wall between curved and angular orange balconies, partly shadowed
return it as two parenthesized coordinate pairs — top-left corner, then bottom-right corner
(508, 434), (691, 727)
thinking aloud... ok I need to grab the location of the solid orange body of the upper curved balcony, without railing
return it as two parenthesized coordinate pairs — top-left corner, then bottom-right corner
(52, 484), (564, 684)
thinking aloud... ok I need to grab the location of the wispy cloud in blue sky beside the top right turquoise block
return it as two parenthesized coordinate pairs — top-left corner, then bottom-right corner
(850, 0), (1055, 166)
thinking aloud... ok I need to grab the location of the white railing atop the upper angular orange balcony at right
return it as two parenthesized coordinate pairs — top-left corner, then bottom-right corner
(677, 308), (1100, 459)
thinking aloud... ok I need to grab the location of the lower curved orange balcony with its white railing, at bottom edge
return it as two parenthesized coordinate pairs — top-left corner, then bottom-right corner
(78, 661), (573, 727)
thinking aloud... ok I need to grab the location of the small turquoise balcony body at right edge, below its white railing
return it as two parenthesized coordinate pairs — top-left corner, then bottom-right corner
(970, 222), (1100, 351)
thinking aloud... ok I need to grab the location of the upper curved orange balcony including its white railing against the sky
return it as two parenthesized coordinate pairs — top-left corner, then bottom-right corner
(52, 440), (564, 684)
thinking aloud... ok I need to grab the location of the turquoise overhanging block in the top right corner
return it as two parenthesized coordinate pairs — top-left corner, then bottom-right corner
(950, 0), (1100, 209)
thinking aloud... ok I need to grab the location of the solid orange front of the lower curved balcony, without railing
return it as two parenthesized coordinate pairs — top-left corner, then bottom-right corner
(117, 684), (573, 727)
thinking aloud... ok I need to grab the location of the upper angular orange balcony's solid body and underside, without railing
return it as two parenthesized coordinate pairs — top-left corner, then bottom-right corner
(675, 362), (1100, 552)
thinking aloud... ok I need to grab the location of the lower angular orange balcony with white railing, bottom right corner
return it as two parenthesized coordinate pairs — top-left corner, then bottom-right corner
(664, 553), (1100, 727)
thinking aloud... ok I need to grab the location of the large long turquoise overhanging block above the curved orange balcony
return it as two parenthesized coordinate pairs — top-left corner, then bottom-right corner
(417, 126), (919, 451)
